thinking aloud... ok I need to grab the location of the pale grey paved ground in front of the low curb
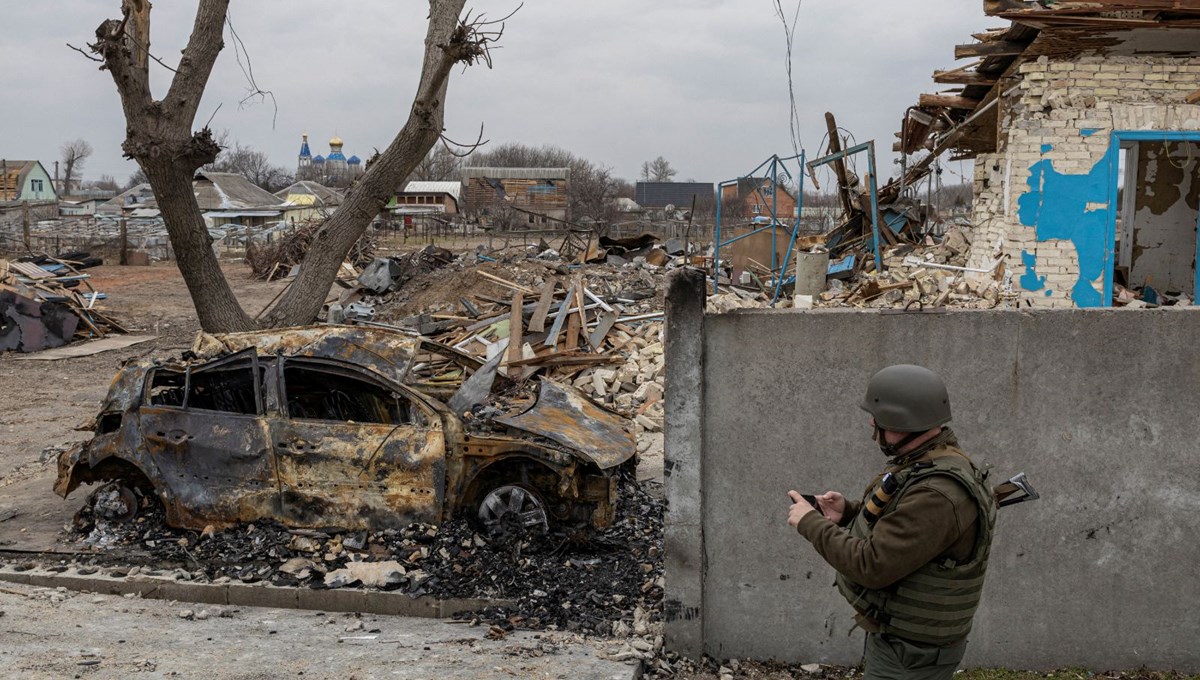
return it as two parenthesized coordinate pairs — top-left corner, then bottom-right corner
(0, 583), (638, 680)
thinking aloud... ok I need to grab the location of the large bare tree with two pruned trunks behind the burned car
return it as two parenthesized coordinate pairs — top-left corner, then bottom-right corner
(89, 0), (503, 332)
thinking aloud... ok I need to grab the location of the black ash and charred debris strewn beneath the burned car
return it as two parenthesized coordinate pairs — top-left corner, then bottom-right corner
(64, 474), (664, 637)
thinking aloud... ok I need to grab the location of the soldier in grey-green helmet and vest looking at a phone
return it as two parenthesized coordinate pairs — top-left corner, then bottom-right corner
(787, 365), (996, 680)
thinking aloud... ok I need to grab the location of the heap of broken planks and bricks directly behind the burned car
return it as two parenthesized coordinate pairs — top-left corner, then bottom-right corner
(328, 242), (684, 453)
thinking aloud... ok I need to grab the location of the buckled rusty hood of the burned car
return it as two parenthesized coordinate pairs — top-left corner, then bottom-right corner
(494, 378), (637, 470)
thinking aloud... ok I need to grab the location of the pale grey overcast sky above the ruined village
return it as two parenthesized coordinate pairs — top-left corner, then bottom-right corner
(0, 0), (998, 189)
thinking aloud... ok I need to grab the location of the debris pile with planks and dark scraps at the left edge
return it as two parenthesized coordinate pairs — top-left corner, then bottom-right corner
(0, 253), (127, 351)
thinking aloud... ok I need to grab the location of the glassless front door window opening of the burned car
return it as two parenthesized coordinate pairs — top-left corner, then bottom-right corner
(283, 362), (413, 425)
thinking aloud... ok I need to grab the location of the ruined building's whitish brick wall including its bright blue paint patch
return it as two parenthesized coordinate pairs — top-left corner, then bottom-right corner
(968, 54), (1200, 307)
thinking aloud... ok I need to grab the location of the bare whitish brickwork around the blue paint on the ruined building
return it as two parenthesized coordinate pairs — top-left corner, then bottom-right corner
(967, 56), (1200, 307)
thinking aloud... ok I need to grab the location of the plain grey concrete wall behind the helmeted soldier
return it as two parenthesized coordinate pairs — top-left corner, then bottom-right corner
(666, 279), (1200, 672)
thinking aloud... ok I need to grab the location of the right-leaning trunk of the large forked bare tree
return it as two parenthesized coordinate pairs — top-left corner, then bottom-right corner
(265, 0), (468, 326)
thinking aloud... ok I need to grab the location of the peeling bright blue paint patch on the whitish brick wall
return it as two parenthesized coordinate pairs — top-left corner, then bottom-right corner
(1016, 150), (1114, 307)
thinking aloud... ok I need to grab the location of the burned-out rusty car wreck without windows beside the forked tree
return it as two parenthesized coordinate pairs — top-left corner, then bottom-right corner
(54, 326), (636, 530)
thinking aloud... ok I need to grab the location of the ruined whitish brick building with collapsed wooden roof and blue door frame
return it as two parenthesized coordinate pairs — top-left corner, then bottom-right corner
(901, 0), (1200, 307)
